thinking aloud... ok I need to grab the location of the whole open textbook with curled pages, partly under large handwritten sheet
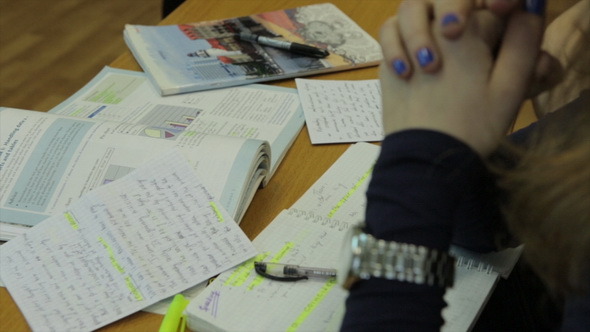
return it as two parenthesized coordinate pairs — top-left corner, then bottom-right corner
(0, 68), (304, 240)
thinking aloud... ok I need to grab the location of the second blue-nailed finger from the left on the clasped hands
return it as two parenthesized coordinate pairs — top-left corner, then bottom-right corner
(398, 0), (441, 73)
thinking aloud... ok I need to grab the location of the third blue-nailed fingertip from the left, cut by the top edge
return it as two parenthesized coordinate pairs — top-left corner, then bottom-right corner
(434, 0), (475, 39)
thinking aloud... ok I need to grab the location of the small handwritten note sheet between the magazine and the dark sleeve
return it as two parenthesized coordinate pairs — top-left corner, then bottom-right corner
(295, 78), (384, 144)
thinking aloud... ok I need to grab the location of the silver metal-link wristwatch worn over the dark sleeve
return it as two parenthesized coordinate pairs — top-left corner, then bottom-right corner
(337, 224), (455, 289)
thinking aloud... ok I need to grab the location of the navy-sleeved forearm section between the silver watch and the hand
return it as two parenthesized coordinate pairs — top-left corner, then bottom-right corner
(366, 130), (500, 250)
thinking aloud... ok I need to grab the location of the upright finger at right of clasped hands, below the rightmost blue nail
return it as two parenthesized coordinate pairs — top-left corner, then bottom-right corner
(490, 12), (543, 111)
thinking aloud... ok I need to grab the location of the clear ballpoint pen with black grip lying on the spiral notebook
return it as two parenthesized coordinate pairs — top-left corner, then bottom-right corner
(254, 262), (336, 281)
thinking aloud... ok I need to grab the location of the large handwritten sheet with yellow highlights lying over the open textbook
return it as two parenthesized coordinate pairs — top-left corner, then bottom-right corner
(0, 152), (255, 331)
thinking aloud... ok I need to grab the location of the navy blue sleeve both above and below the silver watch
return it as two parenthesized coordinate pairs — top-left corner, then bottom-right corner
(342, 130), (490, 331)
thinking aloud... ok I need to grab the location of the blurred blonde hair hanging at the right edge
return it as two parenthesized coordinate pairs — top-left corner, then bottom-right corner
(498, 109), (590, 296)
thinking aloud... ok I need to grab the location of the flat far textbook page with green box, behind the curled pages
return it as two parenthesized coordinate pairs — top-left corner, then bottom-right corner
(50, 67), (305, 183)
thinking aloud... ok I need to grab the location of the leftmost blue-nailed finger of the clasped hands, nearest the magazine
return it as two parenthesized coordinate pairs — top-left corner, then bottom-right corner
(380, 16), (412, 79)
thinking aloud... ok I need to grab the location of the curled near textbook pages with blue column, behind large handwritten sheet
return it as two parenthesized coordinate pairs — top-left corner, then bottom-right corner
(0, 109), (270, 238)
